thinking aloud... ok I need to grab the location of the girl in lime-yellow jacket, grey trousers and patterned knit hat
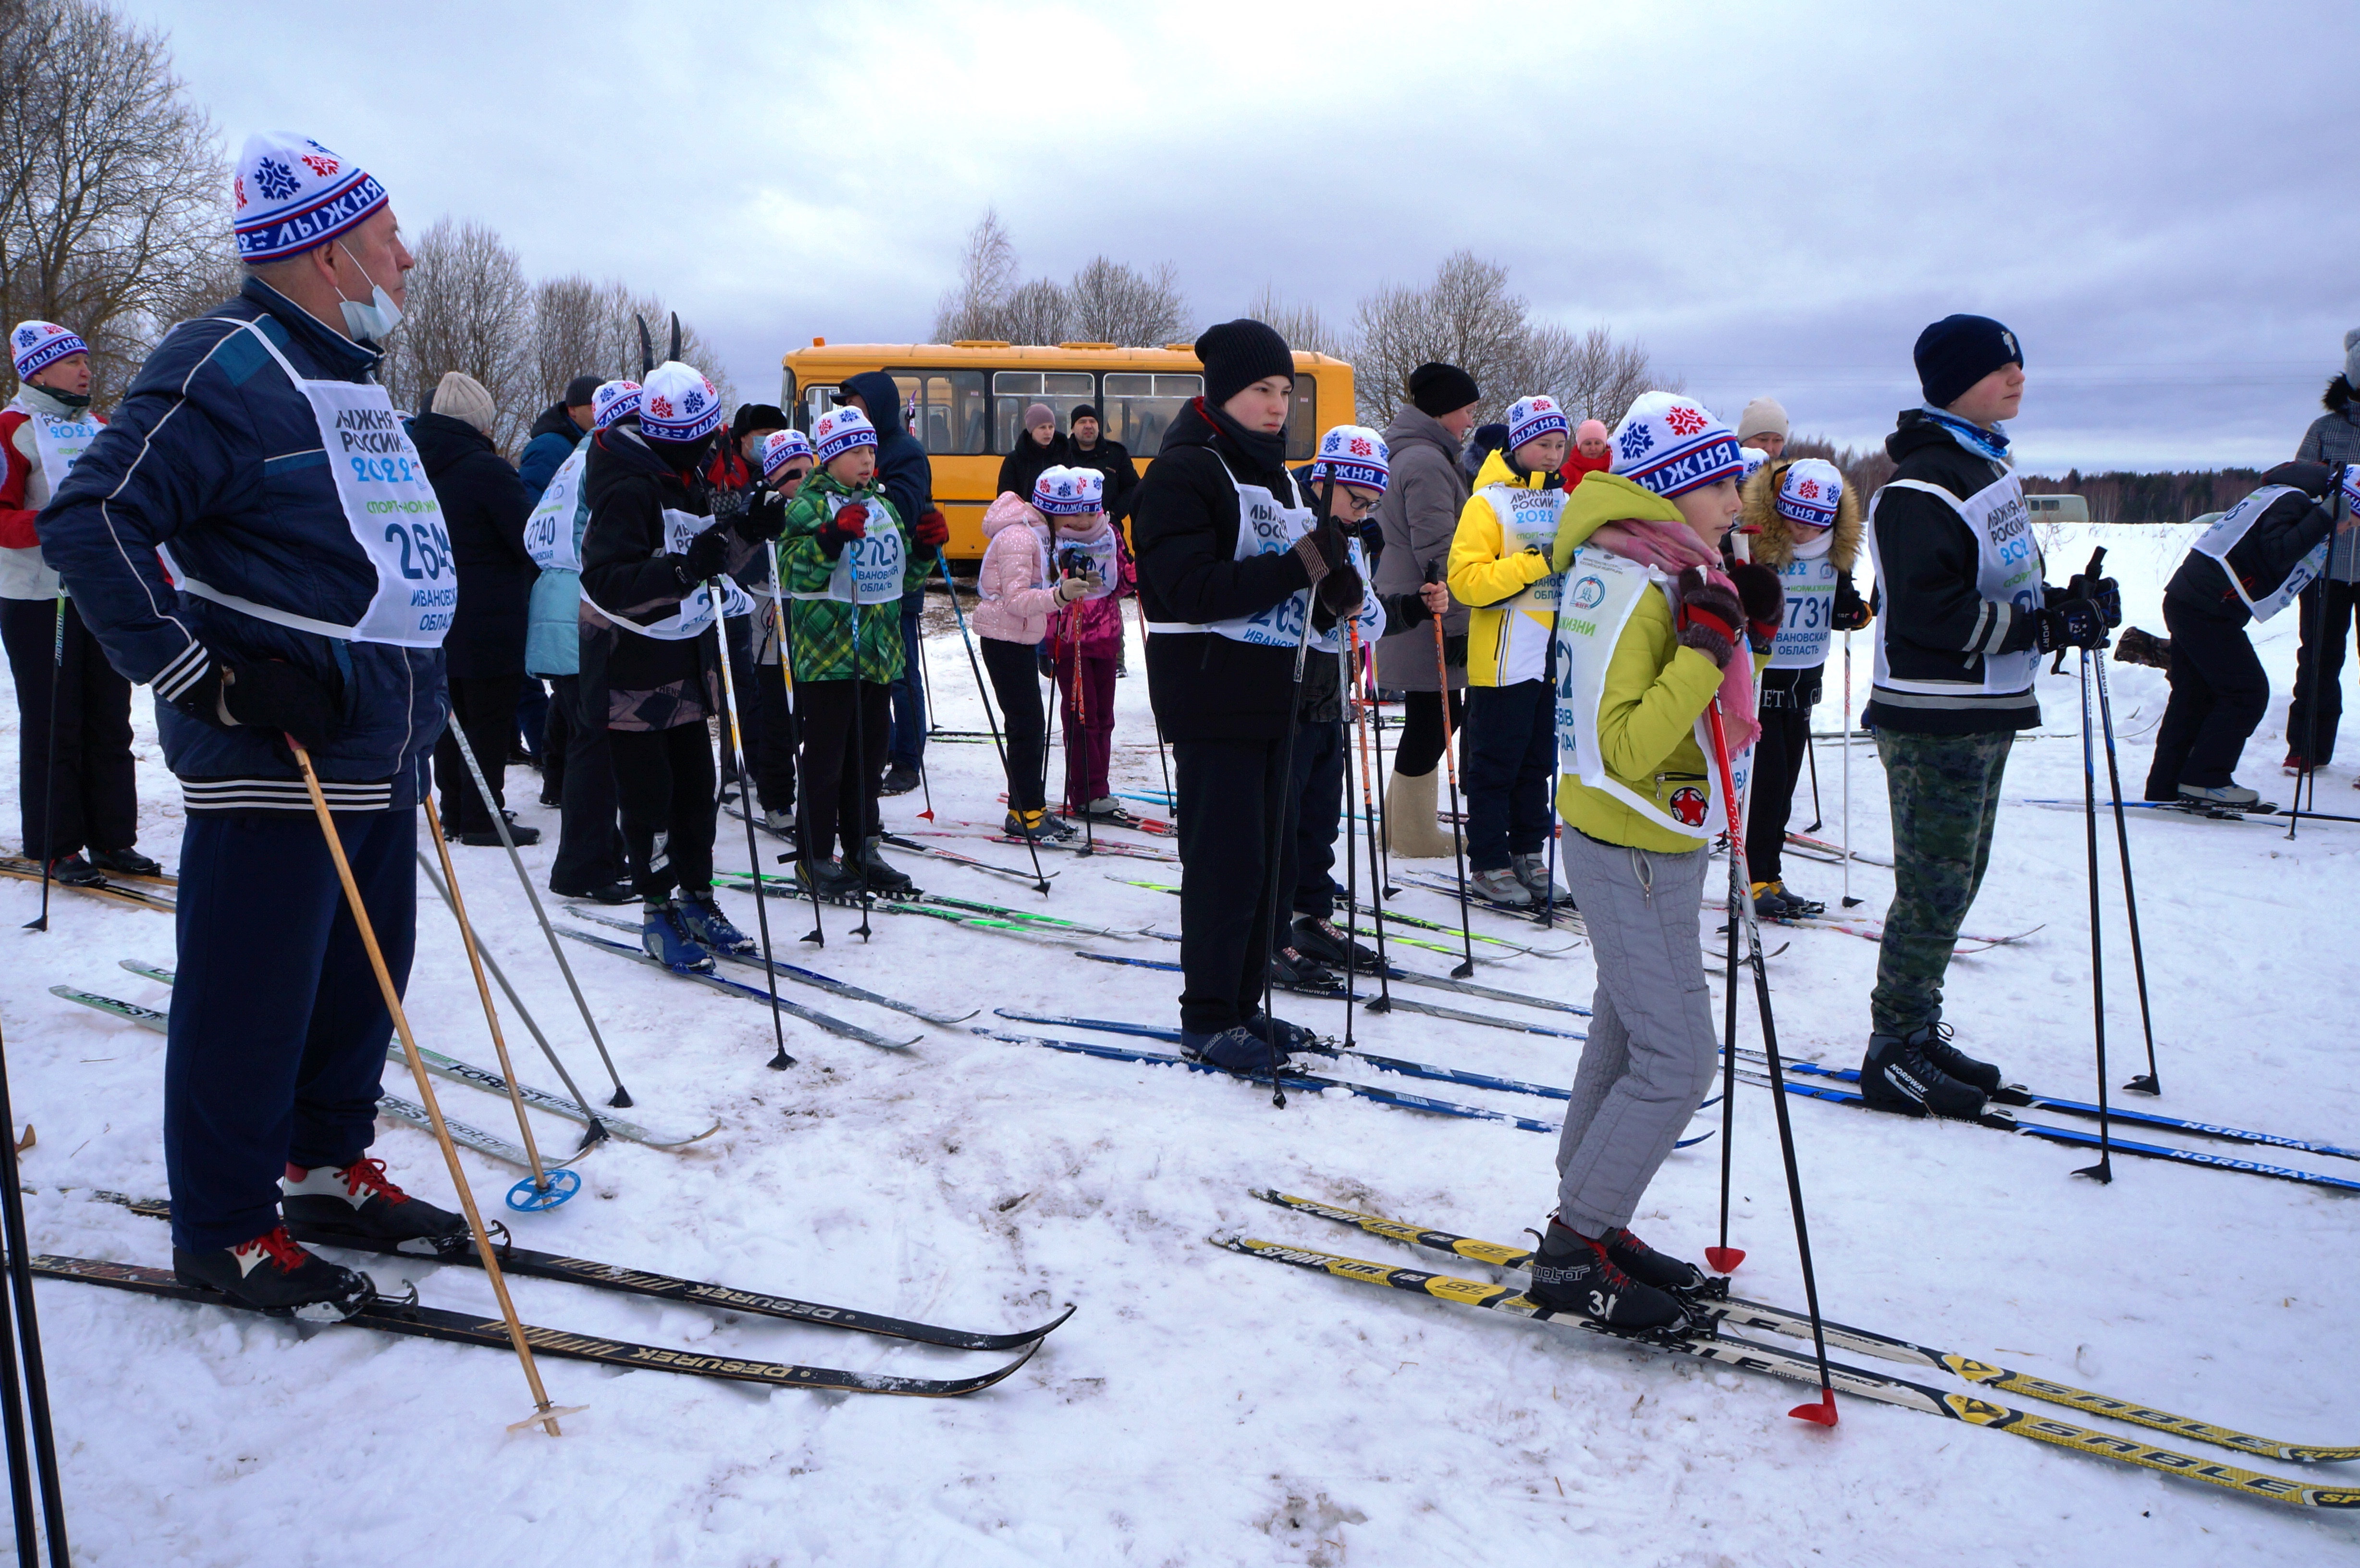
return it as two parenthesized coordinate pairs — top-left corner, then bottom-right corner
(1532, 392), (1782, 1330)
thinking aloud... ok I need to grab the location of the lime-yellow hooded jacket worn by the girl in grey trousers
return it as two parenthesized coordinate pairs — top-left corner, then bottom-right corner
(1550, 475), (1768, 855)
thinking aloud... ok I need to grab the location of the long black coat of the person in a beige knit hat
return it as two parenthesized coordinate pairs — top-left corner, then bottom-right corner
(411, 413), (541, 680)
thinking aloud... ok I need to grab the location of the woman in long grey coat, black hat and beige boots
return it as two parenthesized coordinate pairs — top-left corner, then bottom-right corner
(1376, 364), (1482, 857)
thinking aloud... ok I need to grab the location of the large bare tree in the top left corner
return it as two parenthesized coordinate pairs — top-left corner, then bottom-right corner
(0, 0), (229, 402)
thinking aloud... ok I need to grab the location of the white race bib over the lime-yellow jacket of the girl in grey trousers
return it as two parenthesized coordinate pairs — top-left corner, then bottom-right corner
(1558, 548), (1754, 841)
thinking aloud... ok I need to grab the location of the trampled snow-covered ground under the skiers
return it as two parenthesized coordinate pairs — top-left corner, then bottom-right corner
(0, 527), (2360, 1568)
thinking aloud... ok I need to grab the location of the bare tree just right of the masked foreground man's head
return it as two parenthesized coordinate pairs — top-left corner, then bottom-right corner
(378, 217), (538, 451)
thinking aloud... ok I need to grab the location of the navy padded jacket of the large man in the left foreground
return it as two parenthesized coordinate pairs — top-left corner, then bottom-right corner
(40, 279), (448, 812)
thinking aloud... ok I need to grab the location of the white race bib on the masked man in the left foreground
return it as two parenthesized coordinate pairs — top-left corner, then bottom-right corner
(163, 321), (458, 647)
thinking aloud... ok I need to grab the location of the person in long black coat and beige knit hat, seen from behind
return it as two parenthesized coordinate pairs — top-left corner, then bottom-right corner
(411, 371), (541, 845)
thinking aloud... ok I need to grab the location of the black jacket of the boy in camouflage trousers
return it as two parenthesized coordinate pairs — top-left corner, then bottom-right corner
(1862, 408), (2041, 735)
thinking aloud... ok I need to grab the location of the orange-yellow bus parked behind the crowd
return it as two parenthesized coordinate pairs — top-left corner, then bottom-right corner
(779, 338), (1352, 560)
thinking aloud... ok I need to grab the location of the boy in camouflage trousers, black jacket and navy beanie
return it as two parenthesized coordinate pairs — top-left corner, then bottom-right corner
(1860, 317), (2122, 1119)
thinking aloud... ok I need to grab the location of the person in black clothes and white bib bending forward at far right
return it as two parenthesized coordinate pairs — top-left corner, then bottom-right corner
(2148, 463), (2360, 810)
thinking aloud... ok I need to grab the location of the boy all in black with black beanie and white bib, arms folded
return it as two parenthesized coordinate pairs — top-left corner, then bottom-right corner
(1133, 319), (1362, 1072)
